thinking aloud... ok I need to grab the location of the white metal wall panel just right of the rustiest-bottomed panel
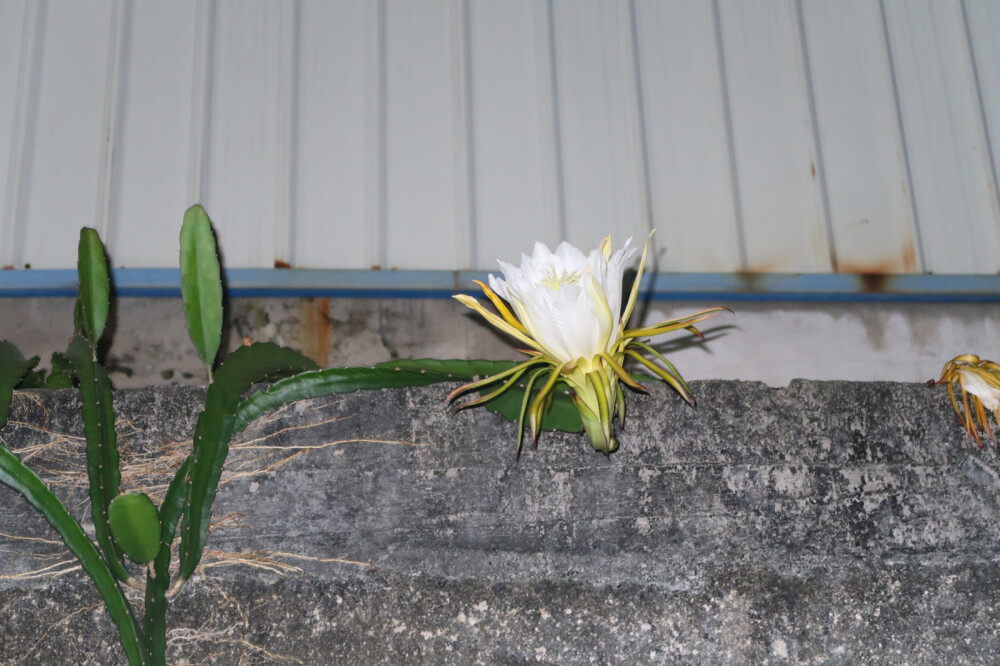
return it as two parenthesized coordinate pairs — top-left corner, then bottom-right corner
(885, 0), (1000, 275)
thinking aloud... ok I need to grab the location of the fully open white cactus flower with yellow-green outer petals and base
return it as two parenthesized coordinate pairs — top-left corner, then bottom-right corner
(448, 237), (727, 453)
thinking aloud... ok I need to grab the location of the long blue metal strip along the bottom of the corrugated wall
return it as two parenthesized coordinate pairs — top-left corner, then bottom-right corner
(0, 268), (1000, 303)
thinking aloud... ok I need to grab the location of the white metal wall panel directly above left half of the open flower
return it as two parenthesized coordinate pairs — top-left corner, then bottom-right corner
(468, 0), (563, 268)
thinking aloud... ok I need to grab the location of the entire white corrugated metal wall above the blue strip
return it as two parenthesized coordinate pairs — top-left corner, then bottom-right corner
(0, 0), (1000, 275)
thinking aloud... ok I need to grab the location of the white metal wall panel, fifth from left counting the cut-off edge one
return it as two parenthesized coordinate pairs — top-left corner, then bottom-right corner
(288, 0), (382, 269)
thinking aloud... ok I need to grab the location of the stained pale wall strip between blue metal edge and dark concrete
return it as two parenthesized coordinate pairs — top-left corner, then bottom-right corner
(0, 290), (1000, 388)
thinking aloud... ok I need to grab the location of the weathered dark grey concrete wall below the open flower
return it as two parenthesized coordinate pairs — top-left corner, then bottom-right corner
(0, 381), (1000, 664)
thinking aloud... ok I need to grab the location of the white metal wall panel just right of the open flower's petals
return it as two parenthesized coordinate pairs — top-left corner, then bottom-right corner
(635, 0), (743, 273)
